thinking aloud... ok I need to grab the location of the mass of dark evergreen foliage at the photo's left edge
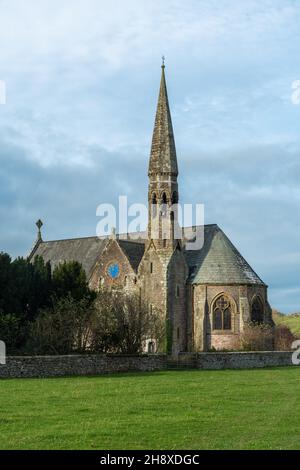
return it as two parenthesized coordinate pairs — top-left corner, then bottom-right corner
(0, 253), (95, 354)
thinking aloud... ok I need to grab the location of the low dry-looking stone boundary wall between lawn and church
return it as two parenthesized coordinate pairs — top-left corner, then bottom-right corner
(0, 351), (300, 379)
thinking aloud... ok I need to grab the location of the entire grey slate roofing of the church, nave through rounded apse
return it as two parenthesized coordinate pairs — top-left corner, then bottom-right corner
(31, 225), (265, 285)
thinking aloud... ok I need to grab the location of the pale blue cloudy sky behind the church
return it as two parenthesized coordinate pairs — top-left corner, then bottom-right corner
(0, 0), (300, 313)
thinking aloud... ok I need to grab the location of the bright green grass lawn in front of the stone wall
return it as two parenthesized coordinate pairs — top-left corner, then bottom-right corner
(0, 367), (300, 450)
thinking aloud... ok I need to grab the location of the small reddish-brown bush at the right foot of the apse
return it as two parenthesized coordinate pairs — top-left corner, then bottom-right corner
(241, 322), (274, 351)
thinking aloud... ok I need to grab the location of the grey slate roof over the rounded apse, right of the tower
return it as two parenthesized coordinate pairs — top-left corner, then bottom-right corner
(185, 225), (265, 285)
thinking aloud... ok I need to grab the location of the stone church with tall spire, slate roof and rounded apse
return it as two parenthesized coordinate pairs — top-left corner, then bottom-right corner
(30, 64), (273, 354)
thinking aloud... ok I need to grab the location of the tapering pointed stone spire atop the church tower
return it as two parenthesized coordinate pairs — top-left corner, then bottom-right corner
(148, 58), (178, 176)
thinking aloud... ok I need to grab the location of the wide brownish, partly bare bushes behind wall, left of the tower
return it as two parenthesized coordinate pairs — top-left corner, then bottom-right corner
(27, 290), (164, 354)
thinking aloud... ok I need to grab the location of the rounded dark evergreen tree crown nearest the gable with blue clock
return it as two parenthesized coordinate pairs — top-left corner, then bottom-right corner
(52, 261), (94, 300)
